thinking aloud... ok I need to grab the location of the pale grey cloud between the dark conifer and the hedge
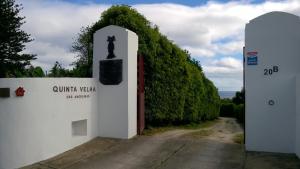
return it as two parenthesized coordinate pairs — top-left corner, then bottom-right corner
(17, 0), (109, 70)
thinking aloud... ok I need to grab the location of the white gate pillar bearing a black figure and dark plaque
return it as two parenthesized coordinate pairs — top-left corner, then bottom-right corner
(93, 25), (138, 138)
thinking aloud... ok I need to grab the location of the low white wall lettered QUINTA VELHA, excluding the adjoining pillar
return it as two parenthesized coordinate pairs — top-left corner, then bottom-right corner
(0, 78), (98, 169)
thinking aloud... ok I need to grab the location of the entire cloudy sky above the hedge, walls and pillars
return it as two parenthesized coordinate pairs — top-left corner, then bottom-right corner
(16, 0), (300, 91)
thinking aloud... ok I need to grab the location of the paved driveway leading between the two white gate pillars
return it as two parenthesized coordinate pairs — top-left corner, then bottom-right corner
(24, 118), (300, 169)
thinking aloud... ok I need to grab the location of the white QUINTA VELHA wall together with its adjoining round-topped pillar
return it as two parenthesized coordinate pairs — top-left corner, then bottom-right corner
(0, 26), (138, 169)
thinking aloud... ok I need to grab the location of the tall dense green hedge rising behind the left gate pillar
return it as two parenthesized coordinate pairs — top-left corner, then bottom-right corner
(73, 5), (220, 125)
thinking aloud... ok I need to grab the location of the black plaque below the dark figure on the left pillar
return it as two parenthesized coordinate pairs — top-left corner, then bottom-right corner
(99, 59), (123, 85)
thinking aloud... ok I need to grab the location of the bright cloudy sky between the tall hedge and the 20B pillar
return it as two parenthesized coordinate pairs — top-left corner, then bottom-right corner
(136, 0), (300, 90)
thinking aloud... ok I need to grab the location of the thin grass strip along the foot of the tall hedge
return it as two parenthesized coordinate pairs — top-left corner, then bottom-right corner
(143, 120), (218, 136)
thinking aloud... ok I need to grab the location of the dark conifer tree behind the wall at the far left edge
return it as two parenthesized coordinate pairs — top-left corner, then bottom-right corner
(0, 0), (36, 78)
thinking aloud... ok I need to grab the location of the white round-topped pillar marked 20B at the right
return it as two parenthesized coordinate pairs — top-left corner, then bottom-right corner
(245, 12), (300, 153)
